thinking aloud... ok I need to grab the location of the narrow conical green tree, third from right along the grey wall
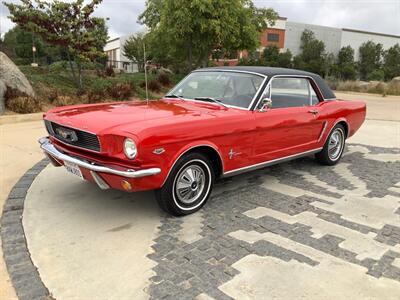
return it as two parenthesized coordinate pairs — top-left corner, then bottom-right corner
(333, 46), (357, 80)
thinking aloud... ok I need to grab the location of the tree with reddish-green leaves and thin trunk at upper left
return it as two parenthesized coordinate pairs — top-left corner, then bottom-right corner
(4, 0), (107, 89)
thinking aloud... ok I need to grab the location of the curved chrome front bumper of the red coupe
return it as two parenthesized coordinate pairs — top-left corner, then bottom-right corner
(39, 137), (161, 178)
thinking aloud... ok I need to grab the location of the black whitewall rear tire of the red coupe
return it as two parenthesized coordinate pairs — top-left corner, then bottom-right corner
(315, 124), (346, 166)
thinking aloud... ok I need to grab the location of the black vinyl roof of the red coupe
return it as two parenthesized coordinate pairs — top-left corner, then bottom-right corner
(197, 66), (336, 99)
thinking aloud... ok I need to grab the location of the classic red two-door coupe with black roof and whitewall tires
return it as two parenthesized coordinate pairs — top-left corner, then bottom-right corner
(39, 67), (366, 216)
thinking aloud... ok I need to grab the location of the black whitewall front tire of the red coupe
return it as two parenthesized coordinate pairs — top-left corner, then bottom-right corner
(156, 152), (215, 216)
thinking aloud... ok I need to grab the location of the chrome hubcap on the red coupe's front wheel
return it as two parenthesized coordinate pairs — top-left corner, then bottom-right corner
(175, 165), (205, 204)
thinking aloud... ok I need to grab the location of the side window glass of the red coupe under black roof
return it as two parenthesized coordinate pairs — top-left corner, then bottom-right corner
(271, 77), (318, 108)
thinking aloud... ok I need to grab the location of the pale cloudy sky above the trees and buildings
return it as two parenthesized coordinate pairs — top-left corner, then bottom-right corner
(0, 0), (400, 38)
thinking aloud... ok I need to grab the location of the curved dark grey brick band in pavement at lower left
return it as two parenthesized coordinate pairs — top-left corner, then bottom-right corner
(0, 159), (52, 300)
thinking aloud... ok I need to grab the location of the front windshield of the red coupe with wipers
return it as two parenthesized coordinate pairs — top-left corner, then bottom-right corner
(167, 71), (264, 108)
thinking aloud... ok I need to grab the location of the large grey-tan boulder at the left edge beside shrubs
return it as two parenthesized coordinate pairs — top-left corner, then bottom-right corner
(0, 52), (35, 114)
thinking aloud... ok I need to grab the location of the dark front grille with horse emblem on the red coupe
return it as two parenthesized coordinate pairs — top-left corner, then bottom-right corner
(44, 120), (100, 152)
